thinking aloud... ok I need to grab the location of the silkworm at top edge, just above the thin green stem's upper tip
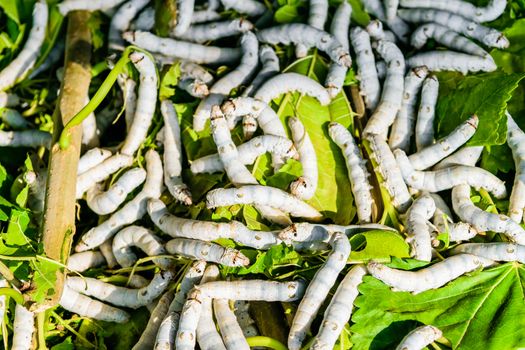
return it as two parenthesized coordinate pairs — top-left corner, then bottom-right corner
(108, 0), (149, 50)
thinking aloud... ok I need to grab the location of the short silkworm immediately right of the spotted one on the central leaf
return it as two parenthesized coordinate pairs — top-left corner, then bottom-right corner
(369, 136), (412, 213)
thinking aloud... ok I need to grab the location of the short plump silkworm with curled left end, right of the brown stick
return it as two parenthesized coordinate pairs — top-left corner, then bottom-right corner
(86, 168), (146, 215)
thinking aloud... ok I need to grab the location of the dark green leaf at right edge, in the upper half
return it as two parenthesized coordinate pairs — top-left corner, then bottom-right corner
(436, 71), (525, 146)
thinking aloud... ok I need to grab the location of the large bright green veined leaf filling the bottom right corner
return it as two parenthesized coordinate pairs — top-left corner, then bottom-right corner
(351, 263), (525, 350)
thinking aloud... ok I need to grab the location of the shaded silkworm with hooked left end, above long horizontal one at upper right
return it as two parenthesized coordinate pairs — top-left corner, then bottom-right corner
(410, 23), (488, 57)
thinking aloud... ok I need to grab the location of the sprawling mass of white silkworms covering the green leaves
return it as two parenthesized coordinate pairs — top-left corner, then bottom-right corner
(0, 0), (525, 350)
